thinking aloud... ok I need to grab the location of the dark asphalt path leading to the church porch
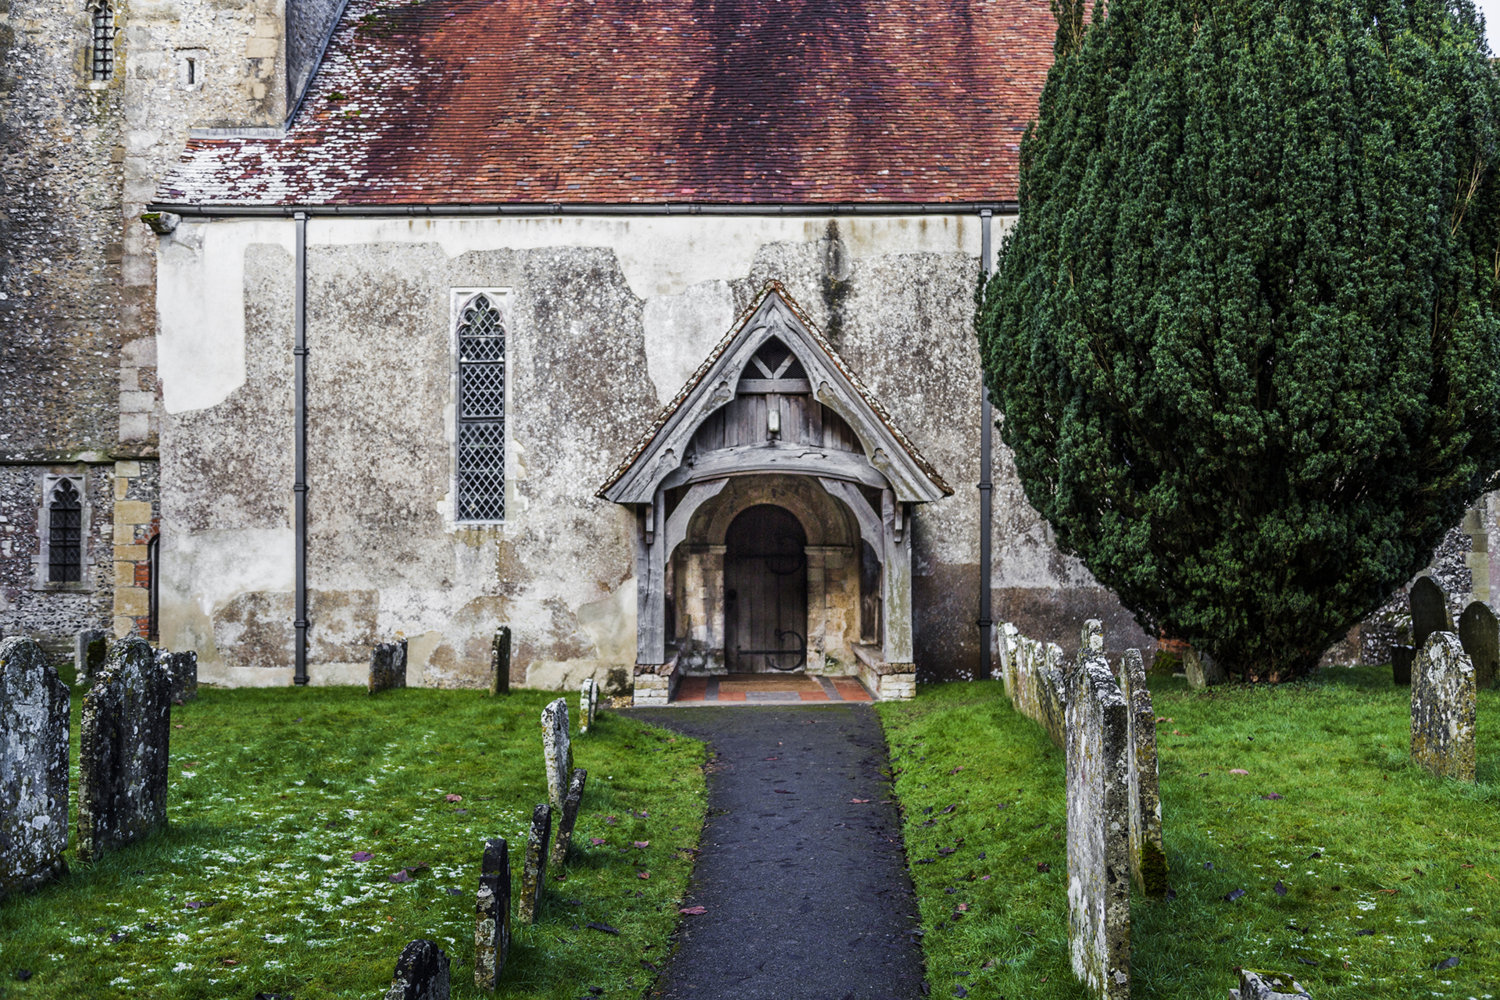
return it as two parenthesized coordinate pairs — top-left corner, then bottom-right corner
(629, 705), (923, 1000)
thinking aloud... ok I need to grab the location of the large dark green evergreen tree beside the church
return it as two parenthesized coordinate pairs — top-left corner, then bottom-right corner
(978, 0), (1500, 681)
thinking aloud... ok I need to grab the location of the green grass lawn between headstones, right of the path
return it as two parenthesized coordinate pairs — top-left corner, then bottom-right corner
(879, 667), (1500, 1000)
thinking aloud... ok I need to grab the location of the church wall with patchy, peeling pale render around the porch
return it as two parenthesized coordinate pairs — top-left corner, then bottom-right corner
(159, 217), (1145, 687)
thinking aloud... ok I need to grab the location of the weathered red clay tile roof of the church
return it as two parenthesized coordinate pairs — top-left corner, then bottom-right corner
(156, 0), (1055, 205)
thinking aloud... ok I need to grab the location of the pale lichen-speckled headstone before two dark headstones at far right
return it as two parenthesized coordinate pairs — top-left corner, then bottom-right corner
(1412, 631), (1476, 781)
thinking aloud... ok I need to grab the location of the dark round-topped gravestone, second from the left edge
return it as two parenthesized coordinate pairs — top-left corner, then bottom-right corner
(78, 636), (173, 861)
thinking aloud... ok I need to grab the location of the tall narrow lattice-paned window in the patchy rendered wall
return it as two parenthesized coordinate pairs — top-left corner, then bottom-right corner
(455, 294), (506, 520)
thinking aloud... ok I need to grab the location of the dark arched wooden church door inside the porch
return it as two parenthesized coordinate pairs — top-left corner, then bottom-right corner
(725, 504), (807, 673)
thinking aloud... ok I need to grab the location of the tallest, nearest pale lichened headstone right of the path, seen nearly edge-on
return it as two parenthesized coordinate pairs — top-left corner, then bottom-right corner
(1067, 652), (1130, 1000)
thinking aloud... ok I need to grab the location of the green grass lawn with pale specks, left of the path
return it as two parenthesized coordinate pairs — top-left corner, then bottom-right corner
(0, 688), (705, 1000)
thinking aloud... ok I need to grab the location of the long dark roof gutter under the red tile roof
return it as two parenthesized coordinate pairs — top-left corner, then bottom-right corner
(147, 201), (1019, 219)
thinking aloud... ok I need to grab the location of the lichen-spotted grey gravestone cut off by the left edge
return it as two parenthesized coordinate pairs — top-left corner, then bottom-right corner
(0, 637), (68, 900)
